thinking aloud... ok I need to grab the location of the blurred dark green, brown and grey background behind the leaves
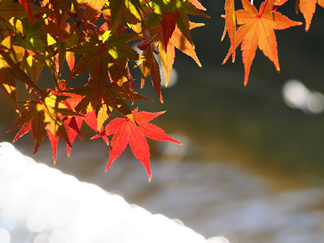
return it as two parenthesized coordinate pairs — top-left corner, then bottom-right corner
(0, 1), (324, 243)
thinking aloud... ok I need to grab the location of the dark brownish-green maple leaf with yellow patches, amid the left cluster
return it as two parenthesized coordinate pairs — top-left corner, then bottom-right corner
(66, 31), (138, 85)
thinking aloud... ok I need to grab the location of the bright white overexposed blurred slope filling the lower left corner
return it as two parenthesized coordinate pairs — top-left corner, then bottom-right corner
(0, 143), (224, 243)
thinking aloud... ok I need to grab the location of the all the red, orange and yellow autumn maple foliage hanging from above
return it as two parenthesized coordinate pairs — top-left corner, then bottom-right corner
(0, 0), (324, 179)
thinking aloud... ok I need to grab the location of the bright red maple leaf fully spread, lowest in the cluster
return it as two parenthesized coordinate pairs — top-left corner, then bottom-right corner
(105, 108), (182, 180)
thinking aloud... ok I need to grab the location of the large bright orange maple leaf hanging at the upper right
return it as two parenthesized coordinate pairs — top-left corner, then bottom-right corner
(223, 0), (302, 85)
